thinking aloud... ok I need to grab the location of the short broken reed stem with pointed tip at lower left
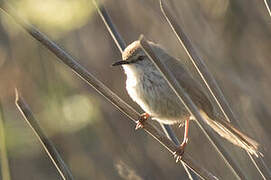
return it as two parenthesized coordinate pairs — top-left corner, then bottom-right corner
(15, 89), (74, 180)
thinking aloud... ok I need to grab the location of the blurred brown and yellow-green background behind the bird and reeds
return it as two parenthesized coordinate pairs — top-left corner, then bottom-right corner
(0, 0), (271, 180)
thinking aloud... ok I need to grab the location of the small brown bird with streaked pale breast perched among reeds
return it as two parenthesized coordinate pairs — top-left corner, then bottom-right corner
(112, 40), (260, 161)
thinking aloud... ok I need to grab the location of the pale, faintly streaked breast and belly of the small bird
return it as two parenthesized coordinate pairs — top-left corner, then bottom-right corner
(124, 66), (189, 124)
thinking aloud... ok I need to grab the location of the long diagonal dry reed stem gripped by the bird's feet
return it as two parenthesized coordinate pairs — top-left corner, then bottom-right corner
(0, 3), (217, 179)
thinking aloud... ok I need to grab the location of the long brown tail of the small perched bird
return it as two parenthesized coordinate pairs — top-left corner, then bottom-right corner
(201, 112), (262, 157)
